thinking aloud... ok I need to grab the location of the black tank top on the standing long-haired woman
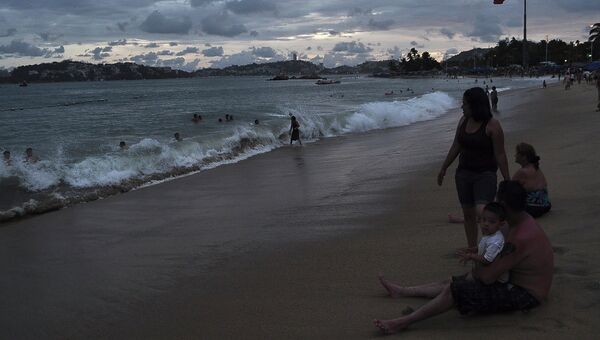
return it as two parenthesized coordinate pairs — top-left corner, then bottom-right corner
(457, 118), (498, 172)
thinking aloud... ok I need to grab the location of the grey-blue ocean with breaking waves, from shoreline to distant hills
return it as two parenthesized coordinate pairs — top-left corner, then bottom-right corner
(0, 76), (542, 221)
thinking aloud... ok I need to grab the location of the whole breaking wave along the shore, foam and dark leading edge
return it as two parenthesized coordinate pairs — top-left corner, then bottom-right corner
(0, 92), (457, 221)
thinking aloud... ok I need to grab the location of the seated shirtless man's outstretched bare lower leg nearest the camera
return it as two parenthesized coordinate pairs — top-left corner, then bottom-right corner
(373, 283), (454, 334)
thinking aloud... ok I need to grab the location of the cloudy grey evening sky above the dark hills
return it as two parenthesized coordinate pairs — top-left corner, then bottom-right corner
(0, 0), (600, 70)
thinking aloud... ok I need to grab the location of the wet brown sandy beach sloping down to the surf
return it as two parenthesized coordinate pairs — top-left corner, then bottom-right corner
(0, 79), (600, 339)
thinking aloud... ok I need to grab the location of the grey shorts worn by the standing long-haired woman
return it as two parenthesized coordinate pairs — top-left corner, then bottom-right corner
(454, 169), (497, 205)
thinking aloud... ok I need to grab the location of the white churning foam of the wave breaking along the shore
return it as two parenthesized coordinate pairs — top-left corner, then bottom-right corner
(0, 92), (456, 191)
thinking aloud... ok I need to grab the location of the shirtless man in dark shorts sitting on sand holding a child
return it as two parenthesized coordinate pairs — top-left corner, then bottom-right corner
(373, 181), (554, 334)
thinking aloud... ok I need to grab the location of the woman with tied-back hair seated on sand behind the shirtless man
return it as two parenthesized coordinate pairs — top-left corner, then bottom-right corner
(512, 143), (552, 217)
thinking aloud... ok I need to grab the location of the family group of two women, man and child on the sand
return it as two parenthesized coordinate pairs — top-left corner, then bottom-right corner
(374, 87), (554, 334)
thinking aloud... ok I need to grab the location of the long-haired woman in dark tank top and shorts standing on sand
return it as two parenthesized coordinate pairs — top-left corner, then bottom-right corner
(437, 87), (510, 248)
